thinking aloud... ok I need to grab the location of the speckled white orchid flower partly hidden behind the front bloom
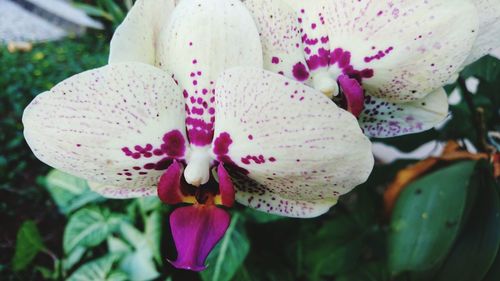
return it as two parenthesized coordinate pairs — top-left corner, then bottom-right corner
(245, 0), (500, 138)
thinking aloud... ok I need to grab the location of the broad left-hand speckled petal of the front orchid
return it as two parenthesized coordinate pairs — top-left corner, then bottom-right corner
(23, 63), (187, 198)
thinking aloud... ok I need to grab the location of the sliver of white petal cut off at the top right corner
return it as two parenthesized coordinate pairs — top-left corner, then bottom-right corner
(465, 0), (500, 65)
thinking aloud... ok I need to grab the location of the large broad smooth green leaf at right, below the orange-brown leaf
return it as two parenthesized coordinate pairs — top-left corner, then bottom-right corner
(388, 161), (476, 273)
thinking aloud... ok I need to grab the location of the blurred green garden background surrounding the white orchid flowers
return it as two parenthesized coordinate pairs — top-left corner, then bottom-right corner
(0, 0), (500, 281)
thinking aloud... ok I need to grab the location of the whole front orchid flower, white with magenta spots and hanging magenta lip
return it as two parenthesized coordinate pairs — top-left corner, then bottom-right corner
(23, 0), (373, 271)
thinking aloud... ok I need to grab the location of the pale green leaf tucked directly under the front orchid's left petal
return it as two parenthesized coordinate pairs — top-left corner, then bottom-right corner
(45, 170), (104, 214)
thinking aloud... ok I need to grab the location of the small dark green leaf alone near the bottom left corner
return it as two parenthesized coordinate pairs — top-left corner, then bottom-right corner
(12, 220), (45, 271)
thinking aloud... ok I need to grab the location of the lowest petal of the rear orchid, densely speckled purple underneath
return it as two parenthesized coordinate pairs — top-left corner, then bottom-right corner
(359, 86), (448, 138)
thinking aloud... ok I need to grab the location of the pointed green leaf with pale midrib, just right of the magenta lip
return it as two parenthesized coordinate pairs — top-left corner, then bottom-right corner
(201, 213), (250, 281)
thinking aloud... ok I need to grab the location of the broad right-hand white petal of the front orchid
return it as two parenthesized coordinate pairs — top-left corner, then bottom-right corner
(213, 68), (373, 216)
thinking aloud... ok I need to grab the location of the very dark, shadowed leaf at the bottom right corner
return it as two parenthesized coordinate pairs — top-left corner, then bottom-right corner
(435, 163), (500, 281)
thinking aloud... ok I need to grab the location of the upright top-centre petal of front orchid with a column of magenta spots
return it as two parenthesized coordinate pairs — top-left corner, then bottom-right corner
(159, 0), (262, 147)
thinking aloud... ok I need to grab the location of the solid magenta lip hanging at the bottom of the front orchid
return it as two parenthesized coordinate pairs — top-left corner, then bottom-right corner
(170, 205), (231, 271)
